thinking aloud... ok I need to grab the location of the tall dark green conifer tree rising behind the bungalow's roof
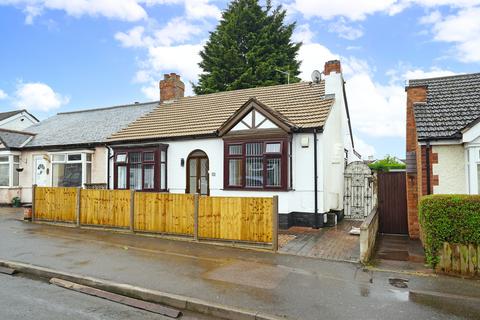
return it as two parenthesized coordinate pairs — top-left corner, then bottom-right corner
(194, 0), (301, 94)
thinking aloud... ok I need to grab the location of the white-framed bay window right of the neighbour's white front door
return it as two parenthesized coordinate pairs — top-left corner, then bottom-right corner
(51, 152), (92, 187)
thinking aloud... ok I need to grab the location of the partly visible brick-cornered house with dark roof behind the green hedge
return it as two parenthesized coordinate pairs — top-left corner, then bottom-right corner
(406, 73), (480, 238)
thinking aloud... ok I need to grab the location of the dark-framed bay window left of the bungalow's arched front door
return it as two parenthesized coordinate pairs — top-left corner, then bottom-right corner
(114, 148), (167, 191)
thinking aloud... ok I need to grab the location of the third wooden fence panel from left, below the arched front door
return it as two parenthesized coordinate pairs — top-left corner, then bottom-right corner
(134, 192), (194, 235)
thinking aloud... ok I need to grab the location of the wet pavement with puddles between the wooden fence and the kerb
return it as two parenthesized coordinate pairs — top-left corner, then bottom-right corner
(0, 208), (480, 320)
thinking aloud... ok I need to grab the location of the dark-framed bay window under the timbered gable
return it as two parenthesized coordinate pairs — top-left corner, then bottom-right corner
(224, 139), (288, 190)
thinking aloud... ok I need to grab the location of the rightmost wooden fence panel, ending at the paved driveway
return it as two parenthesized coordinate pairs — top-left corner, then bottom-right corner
(198, 196), (273, 243)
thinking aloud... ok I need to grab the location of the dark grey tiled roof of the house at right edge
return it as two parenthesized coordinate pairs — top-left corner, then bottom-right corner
(409, 73), (480, 139)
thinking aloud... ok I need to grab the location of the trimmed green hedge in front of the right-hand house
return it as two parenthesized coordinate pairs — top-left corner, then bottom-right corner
(419, 195), (480, 267)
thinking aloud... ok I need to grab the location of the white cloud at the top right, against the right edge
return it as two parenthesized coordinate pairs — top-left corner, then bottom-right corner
(421, 7), (480, 62)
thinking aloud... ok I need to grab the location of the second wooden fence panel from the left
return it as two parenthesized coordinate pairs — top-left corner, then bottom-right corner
(80, 190), (130, 228)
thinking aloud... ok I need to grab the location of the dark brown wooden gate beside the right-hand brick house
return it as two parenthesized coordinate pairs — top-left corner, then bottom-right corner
(378, 172), (408, 234)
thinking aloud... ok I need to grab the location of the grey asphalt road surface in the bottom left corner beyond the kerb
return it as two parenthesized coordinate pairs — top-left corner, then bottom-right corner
(0, 274), (210, 320)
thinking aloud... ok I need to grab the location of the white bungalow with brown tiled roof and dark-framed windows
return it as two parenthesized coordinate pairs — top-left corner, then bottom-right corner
(108, 60), (359, 228)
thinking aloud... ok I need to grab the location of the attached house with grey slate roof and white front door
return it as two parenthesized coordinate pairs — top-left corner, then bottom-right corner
(8, 101), (158, 203)
